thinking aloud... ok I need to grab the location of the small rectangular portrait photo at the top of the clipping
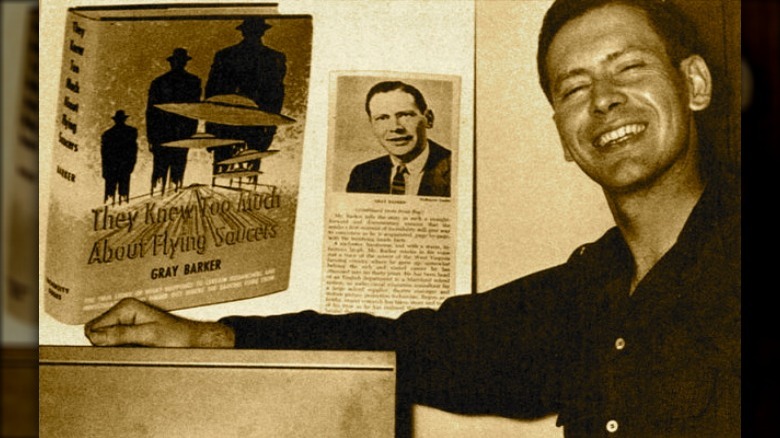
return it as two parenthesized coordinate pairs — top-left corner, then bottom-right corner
(331, 73), (459, 197)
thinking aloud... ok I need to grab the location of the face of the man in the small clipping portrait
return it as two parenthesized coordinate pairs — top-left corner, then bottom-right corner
(368, 90), (433, 162)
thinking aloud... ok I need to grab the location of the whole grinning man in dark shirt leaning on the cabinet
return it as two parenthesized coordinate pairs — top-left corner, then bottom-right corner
(86, 0), (742, 437)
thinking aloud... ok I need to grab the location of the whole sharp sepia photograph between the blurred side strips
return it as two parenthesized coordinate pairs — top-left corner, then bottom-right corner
(29, 0), (744, 438)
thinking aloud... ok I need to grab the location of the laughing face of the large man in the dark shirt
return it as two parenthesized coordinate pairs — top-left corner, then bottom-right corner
(547, 4), (709, 192)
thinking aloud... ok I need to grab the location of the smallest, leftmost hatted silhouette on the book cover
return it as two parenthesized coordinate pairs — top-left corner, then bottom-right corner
(100, 110), (138, 205)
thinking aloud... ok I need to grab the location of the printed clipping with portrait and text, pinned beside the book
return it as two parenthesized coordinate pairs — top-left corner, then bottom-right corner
(323, 72), (460, 316)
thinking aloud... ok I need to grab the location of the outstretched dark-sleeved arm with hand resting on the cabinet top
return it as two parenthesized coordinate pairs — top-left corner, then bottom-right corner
(86, 268), (571, 418)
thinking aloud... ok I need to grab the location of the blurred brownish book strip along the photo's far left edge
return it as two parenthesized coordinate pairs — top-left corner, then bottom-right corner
(0, 2), (38, 336)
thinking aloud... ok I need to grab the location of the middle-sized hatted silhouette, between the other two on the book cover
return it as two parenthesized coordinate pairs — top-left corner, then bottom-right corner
(146, 47), (201, 195)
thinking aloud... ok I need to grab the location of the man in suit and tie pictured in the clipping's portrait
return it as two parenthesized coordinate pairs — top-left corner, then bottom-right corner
(347, 81), (452, 197)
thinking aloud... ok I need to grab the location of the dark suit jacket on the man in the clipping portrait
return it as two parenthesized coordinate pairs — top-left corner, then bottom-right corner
(347, 140), (452, 197)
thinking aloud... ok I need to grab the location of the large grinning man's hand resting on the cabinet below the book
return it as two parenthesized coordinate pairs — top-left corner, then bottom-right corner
(84, 298), (235, 348)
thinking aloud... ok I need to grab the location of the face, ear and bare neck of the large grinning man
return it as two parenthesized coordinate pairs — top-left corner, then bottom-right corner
(544, 1), (712, 293)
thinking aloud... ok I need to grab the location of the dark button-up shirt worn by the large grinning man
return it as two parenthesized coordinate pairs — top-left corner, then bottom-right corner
(221, 176), (741, 437)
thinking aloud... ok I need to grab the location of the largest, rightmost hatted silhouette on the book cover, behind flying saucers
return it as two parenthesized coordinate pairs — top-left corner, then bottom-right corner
(205, 17), (287, 181)
